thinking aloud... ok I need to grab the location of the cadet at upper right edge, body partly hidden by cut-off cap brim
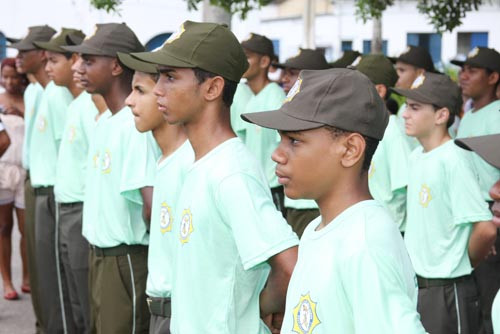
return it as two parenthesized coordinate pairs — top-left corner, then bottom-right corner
(452, 47), (500, 332)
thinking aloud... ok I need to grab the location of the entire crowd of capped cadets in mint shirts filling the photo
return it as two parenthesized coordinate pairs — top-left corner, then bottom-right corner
(0, 21), (500, 334)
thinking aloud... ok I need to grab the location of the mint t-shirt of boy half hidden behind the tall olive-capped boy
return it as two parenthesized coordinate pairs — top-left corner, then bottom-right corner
(146, 140), (194, 298)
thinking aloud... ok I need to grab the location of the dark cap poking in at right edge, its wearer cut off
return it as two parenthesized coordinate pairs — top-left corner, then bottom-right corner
(455, 134), (500, 168)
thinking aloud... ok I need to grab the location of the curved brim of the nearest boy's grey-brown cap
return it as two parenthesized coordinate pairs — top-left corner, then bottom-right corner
(241, 110), (325, 131)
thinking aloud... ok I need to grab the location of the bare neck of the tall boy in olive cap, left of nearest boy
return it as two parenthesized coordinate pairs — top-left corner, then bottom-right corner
(184, 102), (236, 161)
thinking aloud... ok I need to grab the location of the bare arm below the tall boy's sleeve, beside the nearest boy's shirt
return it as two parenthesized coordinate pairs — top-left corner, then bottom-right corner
(260, 246), (298, 317)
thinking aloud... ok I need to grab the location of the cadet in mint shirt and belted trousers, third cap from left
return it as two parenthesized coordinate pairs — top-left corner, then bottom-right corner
(64, 23), (158, 333)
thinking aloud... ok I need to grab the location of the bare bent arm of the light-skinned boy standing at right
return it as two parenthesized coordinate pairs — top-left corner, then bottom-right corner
(469, 221), (497, 268)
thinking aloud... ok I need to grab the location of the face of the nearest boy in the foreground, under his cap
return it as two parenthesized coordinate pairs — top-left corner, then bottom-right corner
(272, 127), (342, 199)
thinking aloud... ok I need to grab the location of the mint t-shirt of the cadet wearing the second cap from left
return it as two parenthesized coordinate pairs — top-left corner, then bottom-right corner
(54, 91), (98, 203)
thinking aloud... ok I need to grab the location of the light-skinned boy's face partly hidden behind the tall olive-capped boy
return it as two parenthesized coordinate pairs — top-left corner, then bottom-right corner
(125, 71), (165, 132)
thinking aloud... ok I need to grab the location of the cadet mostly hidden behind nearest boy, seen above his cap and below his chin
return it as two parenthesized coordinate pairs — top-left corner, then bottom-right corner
(276, 48), (329, 238)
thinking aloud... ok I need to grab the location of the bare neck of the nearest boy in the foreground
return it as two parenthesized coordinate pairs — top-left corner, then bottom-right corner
(316, 169), (372, 230)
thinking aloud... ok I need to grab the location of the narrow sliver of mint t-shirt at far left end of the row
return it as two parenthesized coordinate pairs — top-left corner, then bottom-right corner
(23, 82), (43, 170)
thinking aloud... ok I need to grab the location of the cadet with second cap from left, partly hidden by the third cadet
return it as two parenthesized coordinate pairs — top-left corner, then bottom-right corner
(35, 28), (97, 333)
